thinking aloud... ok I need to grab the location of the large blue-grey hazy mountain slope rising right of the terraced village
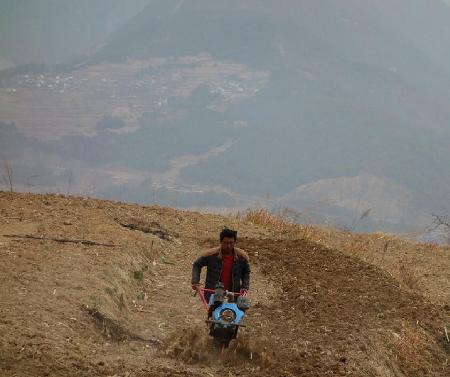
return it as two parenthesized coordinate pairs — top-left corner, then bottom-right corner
(97, 0), (450, 226)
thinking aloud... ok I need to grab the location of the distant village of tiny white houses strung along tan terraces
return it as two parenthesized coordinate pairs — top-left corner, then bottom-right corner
(0, 57), (268, 108)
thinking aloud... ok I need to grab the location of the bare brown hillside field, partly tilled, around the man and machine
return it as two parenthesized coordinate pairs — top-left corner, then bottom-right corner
(0, 192), (450, 377)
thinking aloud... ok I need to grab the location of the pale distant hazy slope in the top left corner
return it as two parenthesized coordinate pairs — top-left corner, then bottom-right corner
(0, 0), (149, 69)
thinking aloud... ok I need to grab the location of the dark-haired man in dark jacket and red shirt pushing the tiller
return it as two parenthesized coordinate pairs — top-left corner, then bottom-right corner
(192, 228), (250, 300)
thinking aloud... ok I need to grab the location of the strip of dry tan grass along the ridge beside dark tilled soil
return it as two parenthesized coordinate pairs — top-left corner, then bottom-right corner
(238, 204), (450, 303)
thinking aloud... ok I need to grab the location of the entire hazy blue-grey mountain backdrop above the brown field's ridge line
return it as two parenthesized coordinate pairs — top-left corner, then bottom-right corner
(0, 0), (450, 239)
